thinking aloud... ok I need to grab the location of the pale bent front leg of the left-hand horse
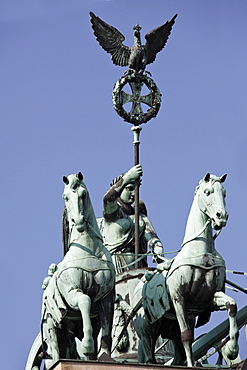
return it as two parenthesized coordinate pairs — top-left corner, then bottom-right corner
(66, 289), (94, 359)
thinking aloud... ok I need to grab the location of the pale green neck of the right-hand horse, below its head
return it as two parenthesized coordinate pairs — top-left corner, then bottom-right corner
(183, 194), (214, 253)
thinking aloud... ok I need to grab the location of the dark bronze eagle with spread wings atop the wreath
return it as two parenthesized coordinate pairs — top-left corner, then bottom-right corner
(89, 12), (177, 73)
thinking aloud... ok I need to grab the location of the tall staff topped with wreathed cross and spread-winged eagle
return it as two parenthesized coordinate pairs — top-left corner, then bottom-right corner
(90, 12), (177, 268)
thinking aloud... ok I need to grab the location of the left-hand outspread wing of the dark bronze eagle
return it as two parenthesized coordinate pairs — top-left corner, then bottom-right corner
(89, 12), (130, 66)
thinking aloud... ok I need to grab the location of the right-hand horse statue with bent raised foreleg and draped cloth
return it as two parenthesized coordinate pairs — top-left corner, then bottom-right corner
(134, 173), (238, 366)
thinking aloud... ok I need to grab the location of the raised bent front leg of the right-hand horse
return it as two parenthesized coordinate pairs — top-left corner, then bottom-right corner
(213, 292), (239, 360)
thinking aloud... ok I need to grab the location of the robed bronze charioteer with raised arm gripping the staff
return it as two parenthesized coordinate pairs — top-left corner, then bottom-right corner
(98, 164), (164, 273)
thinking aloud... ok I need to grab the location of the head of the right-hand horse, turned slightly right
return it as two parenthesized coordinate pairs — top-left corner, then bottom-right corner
(196, 173), (228, 230)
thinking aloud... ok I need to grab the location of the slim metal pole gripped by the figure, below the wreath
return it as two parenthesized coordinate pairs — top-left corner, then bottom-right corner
(131, 126), (142, 268)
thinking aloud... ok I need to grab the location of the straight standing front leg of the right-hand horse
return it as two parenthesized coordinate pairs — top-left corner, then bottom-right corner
(172, 294), (194, 366)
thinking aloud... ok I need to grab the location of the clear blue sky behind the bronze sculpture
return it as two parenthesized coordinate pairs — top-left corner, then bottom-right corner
(0, 0), (247, 370)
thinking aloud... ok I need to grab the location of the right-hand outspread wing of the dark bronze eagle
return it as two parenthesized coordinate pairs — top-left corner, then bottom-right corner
(145, 14), (177, 64)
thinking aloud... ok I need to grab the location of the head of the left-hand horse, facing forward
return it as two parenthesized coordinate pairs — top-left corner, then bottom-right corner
(62, 172), (88, 232)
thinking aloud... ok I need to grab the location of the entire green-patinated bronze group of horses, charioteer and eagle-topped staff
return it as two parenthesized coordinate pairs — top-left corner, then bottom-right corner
(26, 12), (247, 370)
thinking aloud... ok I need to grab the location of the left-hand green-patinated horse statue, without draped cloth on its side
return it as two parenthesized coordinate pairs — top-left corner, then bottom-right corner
(26, 172), (115, 370)
